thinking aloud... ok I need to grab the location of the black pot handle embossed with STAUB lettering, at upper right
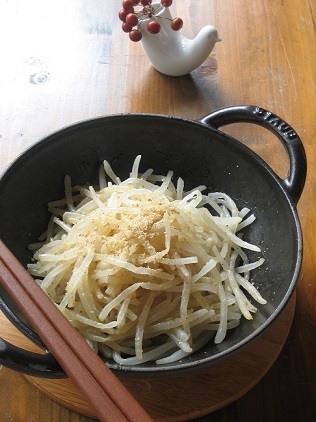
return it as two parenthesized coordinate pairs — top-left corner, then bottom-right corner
(200, 106), (307, 204)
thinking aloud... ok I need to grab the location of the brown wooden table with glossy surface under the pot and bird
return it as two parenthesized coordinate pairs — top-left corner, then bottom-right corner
(0, 0), (316, 422)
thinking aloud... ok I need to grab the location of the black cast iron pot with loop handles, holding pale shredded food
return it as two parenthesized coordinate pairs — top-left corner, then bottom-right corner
(0, 106), (306, 377)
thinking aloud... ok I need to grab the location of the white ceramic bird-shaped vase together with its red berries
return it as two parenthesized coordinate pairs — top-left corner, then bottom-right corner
(119, 0), (221, 76)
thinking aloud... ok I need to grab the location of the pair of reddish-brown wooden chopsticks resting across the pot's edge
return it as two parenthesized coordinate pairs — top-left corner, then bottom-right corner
(0, 240), (152, 422)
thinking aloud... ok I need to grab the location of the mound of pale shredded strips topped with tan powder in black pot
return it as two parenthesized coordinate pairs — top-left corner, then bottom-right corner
(28, 156), (266, 365)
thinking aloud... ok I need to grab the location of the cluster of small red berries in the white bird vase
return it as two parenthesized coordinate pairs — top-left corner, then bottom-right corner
(119, 0), (183, 42)
